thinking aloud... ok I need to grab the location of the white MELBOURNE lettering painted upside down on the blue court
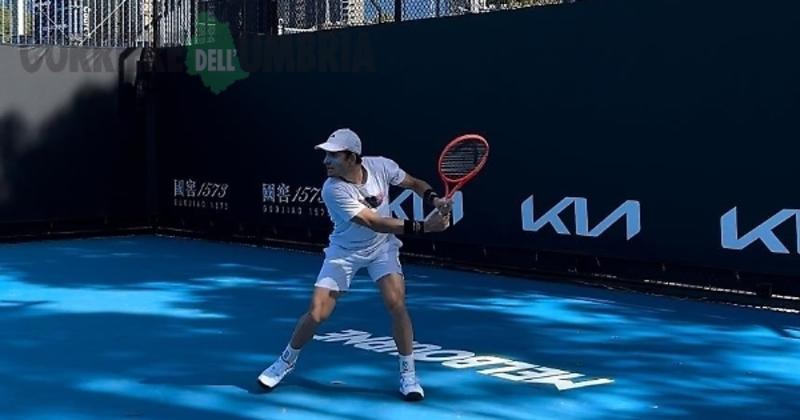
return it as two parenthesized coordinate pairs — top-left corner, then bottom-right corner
(314, 329), (614, 391)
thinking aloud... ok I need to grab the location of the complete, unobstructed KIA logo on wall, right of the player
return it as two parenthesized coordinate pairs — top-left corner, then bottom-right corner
(521, 196), (642, 240)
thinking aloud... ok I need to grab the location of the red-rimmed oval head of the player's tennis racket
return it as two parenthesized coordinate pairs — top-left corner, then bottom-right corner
(439, 134), (489, 198)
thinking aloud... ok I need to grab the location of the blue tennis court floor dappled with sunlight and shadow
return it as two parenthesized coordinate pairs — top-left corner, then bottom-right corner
(0, 236), (800, 419)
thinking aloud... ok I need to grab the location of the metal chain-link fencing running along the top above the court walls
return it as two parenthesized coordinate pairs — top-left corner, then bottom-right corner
(0, 0), (575, 47)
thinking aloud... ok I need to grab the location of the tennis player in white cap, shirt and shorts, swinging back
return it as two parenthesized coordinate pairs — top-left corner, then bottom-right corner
(258, 129), (451, 401)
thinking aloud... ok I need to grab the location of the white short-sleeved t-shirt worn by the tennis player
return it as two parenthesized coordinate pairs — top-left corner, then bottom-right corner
(322, 157), (406, 252)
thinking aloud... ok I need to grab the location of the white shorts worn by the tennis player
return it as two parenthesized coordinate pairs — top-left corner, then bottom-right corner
(314, 237), (403, 292)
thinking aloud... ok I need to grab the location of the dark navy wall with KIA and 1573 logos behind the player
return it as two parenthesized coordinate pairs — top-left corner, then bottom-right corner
(157, 0), (800, 286)
